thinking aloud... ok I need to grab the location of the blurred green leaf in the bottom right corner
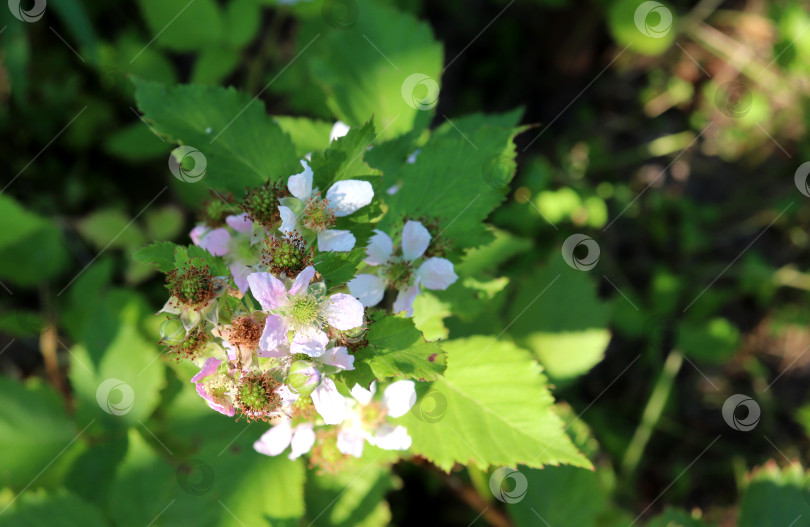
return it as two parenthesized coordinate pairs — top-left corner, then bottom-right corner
(740, 461), (810, 527)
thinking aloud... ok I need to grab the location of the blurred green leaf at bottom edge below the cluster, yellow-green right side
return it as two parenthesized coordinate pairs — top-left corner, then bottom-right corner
(108, 426), (304, 527)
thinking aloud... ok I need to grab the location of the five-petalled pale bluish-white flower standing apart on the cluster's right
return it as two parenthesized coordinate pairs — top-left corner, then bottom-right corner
(347, 221), (458, 316)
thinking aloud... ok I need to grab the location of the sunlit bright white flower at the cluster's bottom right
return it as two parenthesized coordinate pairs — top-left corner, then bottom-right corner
(337, 381), (416, 457)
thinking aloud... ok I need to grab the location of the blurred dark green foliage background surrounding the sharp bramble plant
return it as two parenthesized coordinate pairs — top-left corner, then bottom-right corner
(0, 0), (810, 527)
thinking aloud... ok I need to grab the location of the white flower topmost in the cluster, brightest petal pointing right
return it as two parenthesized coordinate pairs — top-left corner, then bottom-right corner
(278, 161), (374, 251)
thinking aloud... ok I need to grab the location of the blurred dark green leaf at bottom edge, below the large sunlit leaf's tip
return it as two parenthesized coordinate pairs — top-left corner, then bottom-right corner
(504, 466), (607, 527)
